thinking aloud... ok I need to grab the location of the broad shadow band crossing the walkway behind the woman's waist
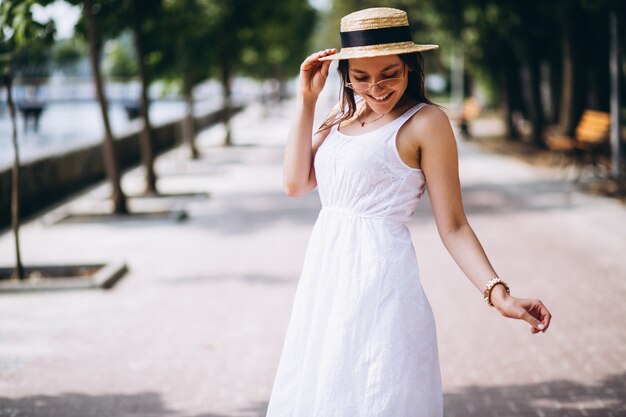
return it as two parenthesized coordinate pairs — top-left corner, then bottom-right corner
(39, 181), (580, 235)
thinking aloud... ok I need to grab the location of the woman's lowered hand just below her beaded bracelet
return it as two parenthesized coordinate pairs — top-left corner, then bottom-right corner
(491, 285), (552, 334)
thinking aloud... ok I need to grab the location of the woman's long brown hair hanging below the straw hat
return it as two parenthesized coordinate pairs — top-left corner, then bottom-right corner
(317, 52), (433, 132)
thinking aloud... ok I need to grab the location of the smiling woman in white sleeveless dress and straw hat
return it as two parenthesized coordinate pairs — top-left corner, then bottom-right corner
(267, 8), (551, 417)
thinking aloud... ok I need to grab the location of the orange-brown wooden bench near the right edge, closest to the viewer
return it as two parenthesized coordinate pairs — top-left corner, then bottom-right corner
(545, 110), (611, 181)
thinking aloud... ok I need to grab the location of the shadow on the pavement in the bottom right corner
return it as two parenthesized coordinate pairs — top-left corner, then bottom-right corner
(444, 373), (626, 417)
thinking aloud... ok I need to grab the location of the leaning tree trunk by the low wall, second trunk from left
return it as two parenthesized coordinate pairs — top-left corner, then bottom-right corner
(84, 0), (128, 214)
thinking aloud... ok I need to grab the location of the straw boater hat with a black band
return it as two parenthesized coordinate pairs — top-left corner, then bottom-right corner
(319, 7), (439, 61)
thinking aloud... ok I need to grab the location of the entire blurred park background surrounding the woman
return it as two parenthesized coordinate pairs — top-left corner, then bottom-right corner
(0, 0), (626, 417)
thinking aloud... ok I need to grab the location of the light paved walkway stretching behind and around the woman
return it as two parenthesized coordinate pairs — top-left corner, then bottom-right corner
(0, 99), (626, 417)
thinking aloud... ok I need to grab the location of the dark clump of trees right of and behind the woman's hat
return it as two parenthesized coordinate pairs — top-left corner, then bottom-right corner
(330, 0), (626, 147)
